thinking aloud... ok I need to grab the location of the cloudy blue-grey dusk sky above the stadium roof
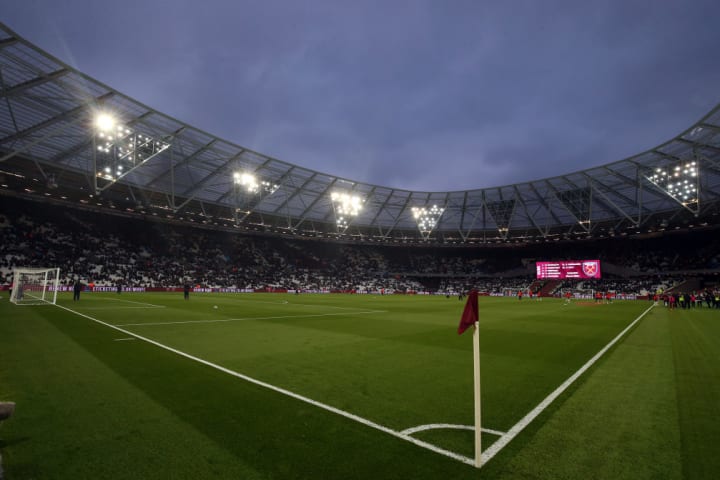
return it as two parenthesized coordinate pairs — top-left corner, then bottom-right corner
(0, 0), (720, 191)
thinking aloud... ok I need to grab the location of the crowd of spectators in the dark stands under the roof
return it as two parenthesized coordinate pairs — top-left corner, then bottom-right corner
(0, 198), (720, 295)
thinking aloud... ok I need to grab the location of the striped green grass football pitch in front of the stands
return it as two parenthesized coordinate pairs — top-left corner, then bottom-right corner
(0, 292), (720, 479)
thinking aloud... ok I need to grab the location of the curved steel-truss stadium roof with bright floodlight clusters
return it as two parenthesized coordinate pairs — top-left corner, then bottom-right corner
(0, 23), (720, 244)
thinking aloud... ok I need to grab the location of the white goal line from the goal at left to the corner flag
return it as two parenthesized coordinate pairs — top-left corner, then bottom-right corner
(55, 304), (475, 465)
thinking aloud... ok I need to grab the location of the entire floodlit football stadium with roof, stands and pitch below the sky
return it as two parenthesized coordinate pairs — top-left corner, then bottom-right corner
(0, 18), (720, 479)
